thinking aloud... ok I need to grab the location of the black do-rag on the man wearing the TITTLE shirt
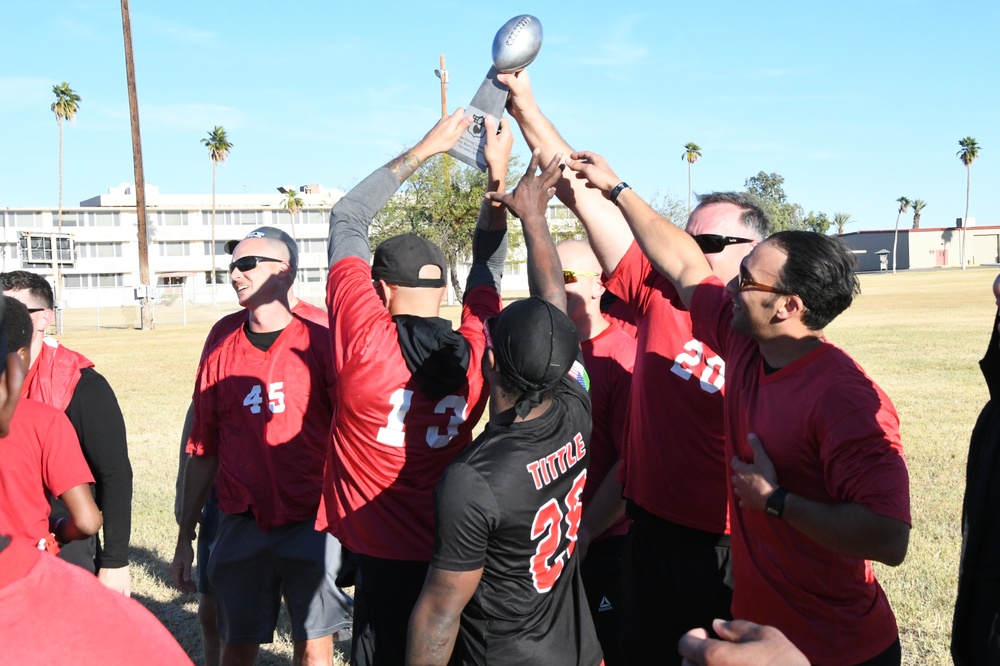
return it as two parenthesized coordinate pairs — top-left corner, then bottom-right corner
(490, 296), (580, 418)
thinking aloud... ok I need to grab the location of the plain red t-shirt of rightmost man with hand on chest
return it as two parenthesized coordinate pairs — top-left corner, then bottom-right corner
(691, 278), (910, 666)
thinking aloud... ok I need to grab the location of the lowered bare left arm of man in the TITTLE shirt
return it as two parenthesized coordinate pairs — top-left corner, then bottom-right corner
(406, 566), (483, 666)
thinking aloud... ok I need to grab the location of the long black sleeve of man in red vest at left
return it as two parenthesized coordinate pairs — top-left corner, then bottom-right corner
(66, 368), (132, 569)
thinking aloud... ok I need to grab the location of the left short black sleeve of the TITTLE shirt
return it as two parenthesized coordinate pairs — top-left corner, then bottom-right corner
(431, 463), (499, 571)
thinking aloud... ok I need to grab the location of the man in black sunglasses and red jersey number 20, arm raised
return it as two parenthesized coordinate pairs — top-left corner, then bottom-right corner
(499, 70), (769, 664)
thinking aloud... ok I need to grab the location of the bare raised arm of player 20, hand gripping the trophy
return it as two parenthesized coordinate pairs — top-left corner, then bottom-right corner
(497, 69), (632, 274)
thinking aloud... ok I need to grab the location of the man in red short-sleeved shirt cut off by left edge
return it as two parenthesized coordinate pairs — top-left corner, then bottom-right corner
(0, 296), (102, 553)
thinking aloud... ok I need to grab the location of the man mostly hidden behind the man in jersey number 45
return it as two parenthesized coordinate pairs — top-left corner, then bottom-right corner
(174, 227), (330, 666)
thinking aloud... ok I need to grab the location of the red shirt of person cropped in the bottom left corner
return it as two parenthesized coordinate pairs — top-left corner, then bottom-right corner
(0, 536), (191, 666)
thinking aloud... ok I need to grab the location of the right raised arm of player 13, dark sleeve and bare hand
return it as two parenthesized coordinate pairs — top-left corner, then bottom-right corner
(465, 116), (514, 294)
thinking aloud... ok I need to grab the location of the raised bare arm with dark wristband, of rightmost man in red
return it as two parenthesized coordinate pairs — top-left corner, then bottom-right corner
(566, 152), (712, 307)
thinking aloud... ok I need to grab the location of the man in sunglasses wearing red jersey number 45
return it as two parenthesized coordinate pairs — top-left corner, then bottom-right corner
(171, 227), (351, 664)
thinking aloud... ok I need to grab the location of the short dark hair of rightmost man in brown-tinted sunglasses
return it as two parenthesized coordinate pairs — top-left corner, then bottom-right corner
(767, 230), (861, 331)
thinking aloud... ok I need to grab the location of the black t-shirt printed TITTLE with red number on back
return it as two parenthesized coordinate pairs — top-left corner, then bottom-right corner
(432, 366), (601, 666)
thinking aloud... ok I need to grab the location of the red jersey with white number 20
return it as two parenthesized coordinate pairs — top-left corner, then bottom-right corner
(605, 242), (729, 534)
